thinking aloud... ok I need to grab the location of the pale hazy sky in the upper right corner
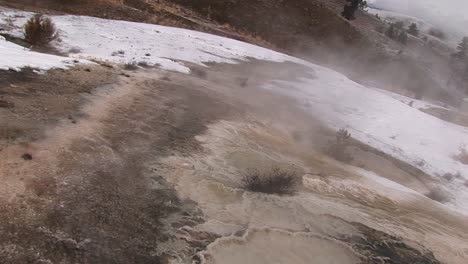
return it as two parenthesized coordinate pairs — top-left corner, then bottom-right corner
(368, 0), (468, 36)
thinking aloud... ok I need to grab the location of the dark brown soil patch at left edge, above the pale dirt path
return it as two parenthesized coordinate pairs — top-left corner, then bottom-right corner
(0, 67), (116, 150)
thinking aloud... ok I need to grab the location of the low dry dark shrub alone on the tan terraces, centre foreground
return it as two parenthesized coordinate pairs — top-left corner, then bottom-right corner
(242, 167), (301, 195)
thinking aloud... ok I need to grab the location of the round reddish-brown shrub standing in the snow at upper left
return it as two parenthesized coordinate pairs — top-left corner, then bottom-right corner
(24, 14), (58, 45)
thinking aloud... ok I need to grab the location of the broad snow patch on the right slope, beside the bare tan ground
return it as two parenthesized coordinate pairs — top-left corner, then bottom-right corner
(264, 68), (468, 211)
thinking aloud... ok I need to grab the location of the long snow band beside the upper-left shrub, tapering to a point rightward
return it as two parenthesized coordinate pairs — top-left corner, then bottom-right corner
(0, 9), (299, 73)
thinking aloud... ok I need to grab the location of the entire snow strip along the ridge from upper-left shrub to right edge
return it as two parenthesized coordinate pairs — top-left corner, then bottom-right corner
(0, 9), (468, 212)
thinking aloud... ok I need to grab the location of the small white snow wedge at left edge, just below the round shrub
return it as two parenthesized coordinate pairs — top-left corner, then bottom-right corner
(0, 36), (83, 71)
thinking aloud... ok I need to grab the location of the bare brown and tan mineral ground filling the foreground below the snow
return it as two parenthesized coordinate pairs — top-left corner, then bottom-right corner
(0, 61), (468, 264)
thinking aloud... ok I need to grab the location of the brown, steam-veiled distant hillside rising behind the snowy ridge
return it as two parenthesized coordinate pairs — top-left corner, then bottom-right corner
(0, 0), (463, 105)
